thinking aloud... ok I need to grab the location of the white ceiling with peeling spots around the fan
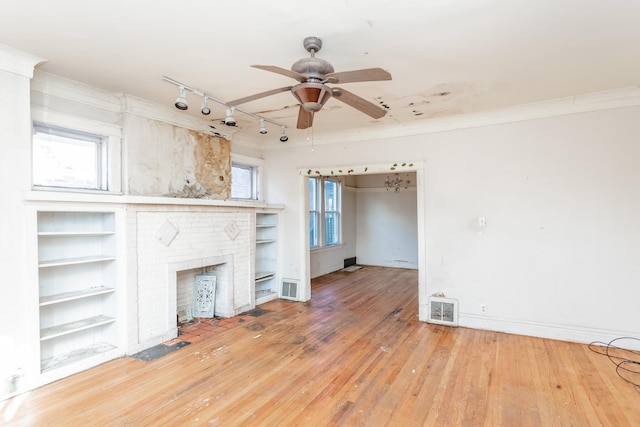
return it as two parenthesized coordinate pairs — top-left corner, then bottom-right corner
(0, 0), (640, 140)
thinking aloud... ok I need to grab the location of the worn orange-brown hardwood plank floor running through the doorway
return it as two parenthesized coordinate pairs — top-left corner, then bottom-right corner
(0, 267), (640, 426)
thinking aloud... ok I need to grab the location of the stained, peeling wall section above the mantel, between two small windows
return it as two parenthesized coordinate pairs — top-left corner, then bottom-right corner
(123, 114), (231, 200)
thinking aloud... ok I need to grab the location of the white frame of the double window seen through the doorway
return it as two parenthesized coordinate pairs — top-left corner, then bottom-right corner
(307, 176), (342, 251)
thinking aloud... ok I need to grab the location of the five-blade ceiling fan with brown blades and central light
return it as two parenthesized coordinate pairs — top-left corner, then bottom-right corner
(226, 37), (391, 129)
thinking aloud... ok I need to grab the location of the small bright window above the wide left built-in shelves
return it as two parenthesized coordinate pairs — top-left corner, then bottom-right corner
(32, 123), (109, 190)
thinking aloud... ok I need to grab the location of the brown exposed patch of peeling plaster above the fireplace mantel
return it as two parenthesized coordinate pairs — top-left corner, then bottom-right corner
(191, 131), (231, 200)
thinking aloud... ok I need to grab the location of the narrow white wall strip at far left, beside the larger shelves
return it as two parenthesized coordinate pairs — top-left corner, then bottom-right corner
(0, 45), (40, 399)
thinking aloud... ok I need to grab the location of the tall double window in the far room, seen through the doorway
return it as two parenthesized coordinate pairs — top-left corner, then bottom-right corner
(309, 177), (342, 248)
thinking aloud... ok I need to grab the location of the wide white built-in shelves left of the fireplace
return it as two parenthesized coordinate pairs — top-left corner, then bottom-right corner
(37, 211), (118, 373)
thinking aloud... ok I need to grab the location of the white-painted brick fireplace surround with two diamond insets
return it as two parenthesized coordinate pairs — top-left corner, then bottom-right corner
(126, 205), (255, 350)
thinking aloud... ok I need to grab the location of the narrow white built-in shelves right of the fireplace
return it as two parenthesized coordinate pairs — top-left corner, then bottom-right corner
(255, 212), (278, 305)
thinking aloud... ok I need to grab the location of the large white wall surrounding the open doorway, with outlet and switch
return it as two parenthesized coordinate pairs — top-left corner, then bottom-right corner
(265, 106), (640, 348)
